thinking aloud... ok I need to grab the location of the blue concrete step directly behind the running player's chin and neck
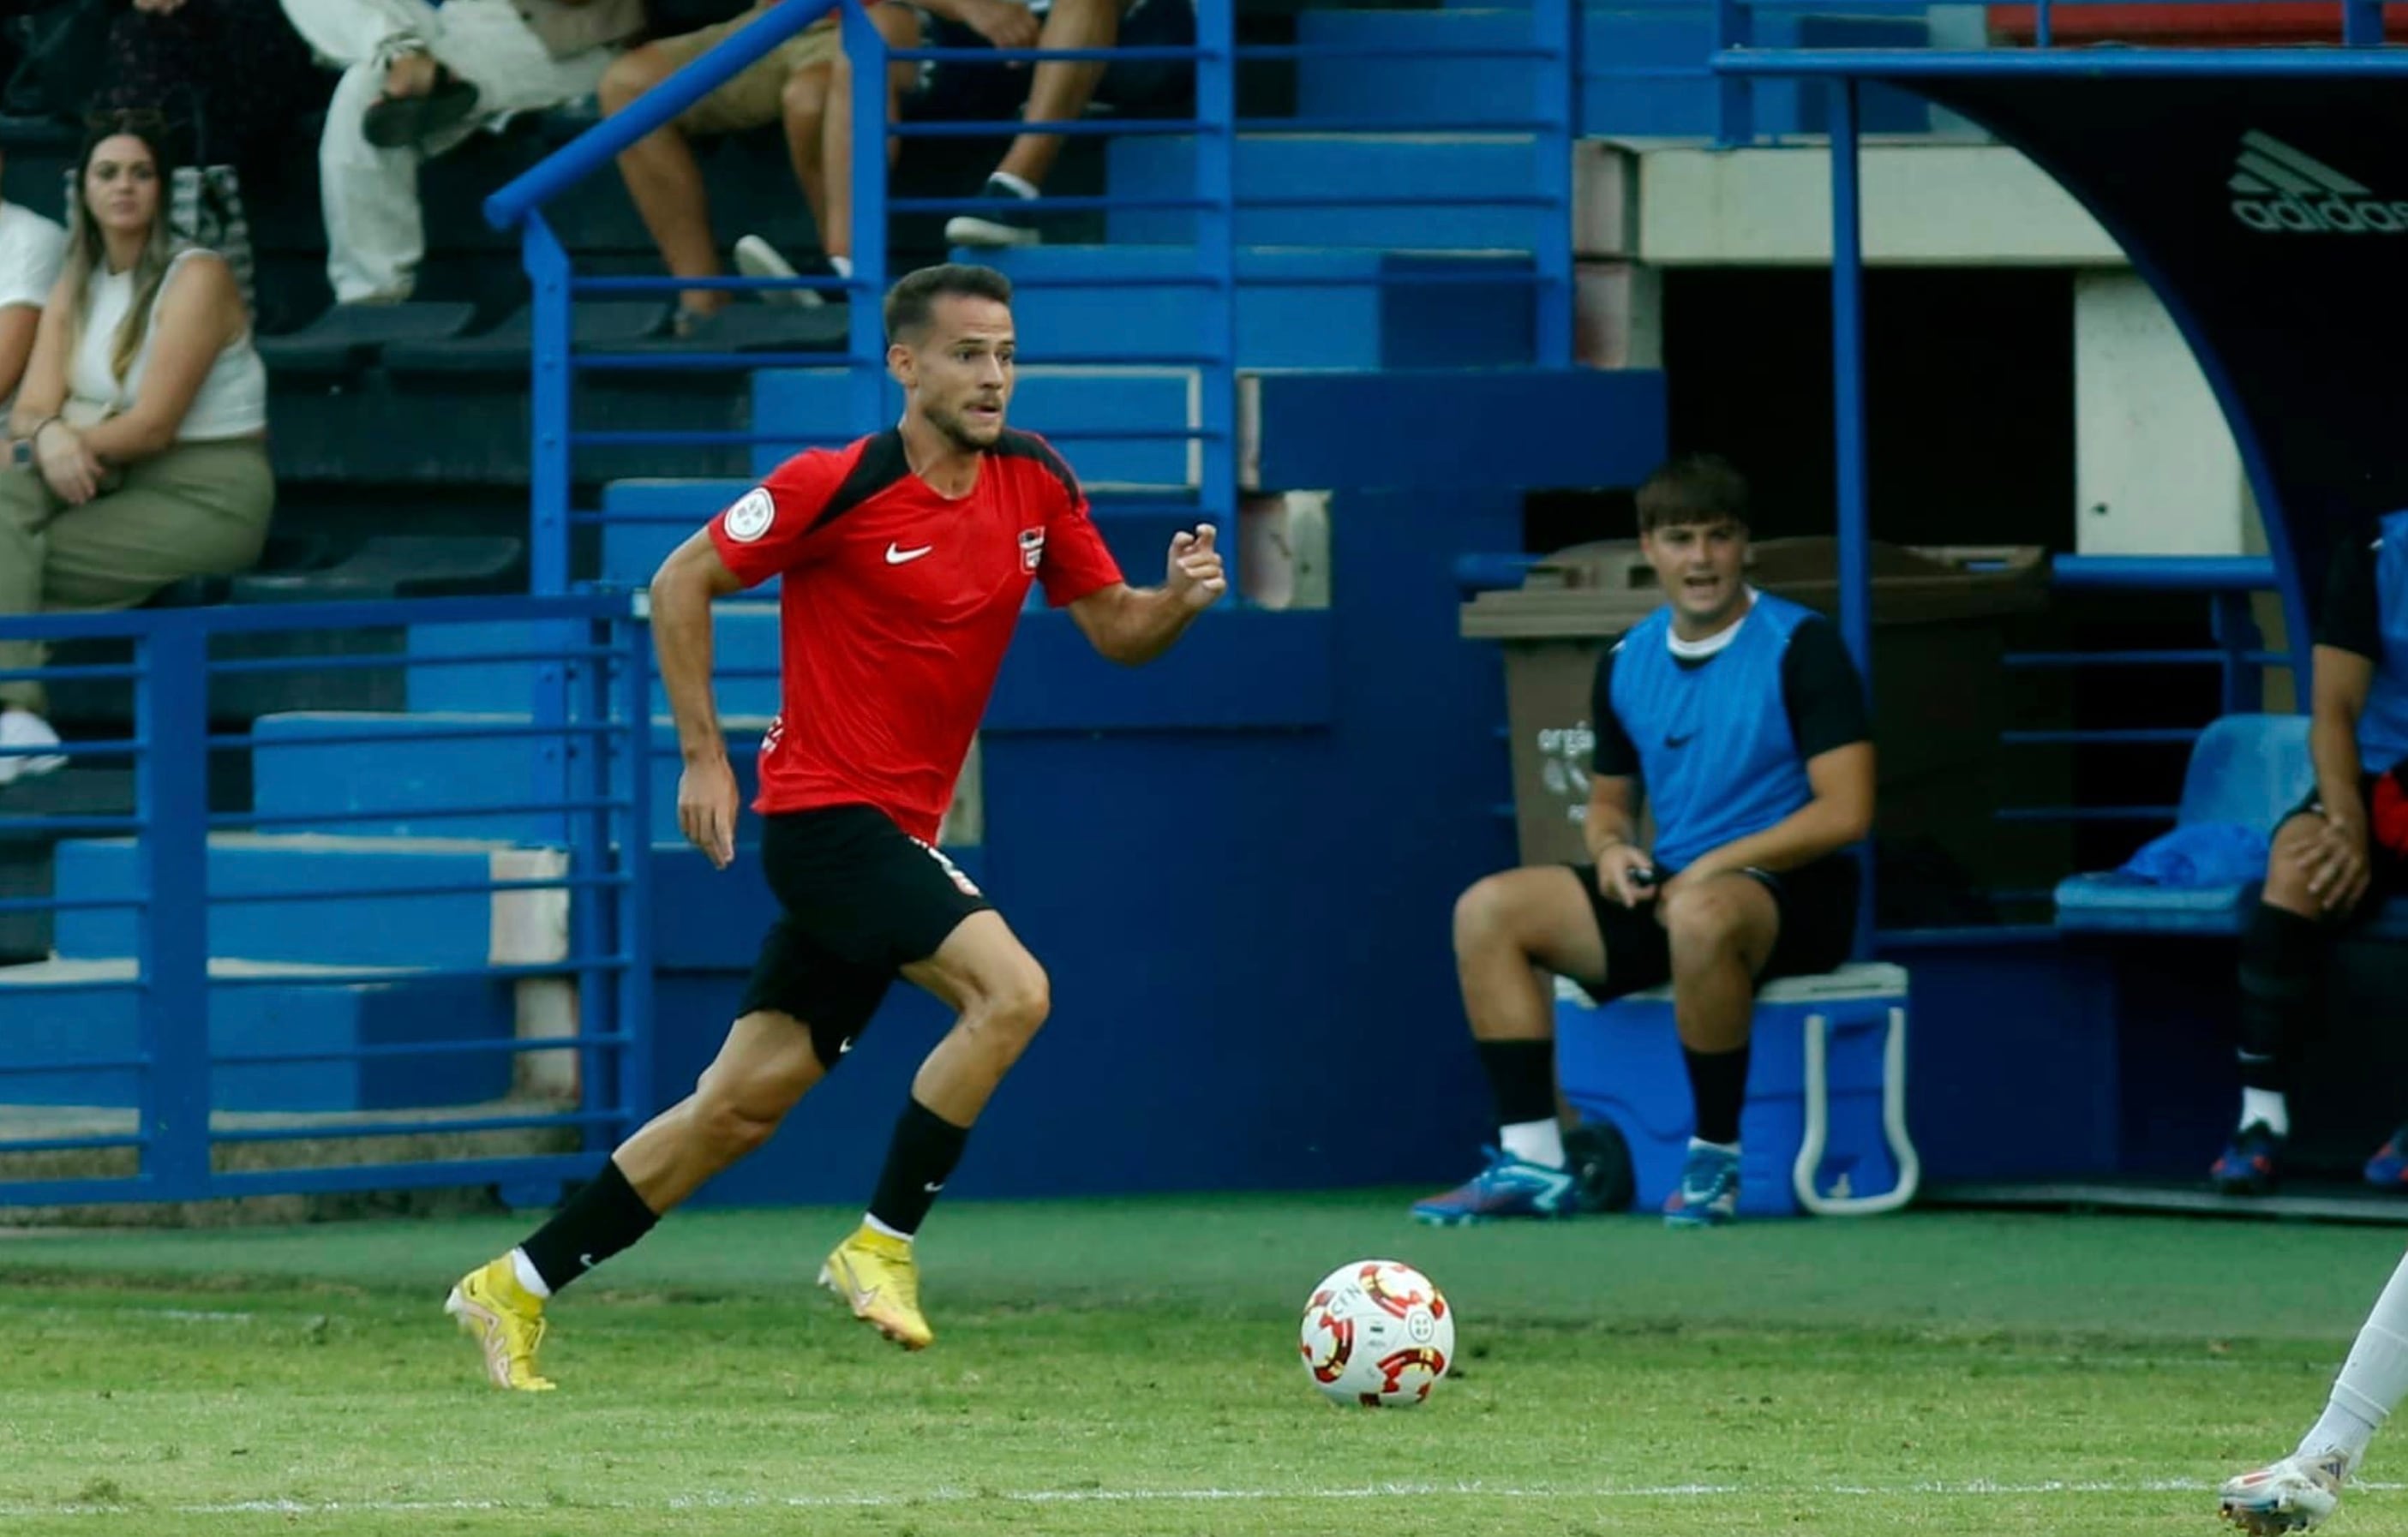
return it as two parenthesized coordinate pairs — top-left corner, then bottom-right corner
(752, 366), (1204, 487)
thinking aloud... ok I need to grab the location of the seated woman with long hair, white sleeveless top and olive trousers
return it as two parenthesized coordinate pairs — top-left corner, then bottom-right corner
(0, 113), (277, 783)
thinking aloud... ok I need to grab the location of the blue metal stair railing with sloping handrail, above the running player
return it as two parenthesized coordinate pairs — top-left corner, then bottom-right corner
(484, 0), (1578, 592)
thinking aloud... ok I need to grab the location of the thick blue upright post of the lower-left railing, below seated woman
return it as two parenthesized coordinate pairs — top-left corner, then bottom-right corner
(135, 612), (209, 1199)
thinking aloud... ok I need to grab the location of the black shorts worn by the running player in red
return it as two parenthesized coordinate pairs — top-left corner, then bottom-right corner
(737, 807), (995, 1068)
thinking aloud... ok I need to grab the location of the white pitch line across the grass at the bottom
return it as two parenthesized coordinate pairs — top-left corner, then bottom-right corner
(0, 1480), (2408, 1518)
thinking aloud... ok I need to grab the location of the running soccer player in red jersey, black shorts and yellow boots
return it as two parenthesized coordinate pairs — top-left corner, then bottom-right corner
(446, 265), (1228, 1390)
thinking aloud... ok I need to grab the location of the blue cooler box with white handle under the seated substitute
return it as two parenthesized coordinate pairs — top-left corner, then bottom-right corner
(1555, 964), (1921, 1217)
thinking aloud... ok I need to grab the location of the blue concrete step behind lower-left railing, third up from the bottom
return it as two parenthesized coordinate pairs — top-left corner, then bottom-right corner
(250, 711), (768, 843)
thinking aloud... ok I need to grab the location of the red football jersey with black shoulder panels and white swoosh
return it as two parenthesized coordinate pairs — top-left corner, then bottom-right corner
(710, 429), (1120, 843)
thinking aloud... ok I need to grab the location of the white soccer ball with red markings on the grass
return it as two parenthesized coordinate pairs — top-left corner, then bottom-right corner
(1298, 1260), (1454, 1409)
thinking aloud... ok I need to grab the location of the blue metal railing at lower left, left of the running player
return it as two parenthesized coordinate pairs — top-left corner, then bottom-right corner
(0, 595), (653, 1205)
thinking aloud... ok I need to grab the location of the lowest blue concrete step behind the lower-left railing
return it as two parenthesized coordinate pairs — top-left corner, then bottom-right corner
(0, 959), (518, 1110)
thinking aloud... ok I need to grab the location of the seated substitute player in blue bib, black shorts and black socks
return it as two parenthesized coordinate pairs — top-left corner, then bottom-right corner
(1413, 458), (1873, 1226)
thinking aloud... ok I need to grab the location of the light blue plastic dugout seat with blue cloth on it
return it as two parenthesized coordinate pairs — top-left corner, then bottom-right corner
(2057, 715), (2408, 937)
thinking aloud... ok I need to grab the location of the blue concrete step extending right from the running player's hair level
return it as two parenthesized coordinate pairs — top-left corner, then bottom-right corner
(953, 245), (1536, 371)
